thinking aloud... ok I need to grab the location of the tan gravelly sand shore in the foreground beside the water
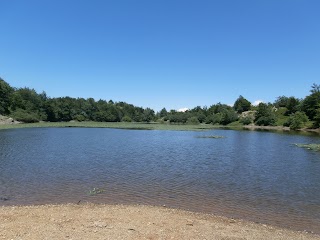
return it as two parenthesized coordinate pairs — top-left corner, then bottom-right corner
(0, 204), (320, 240)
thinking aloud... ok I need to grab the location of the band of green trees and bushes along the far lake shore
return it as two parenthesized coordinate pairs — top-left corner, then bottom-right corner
(0, 78), (320, 129)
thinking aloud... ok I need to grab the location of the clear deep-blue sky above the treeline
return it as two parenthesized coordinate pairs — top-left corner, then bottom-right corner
(0, 0), (320, 110)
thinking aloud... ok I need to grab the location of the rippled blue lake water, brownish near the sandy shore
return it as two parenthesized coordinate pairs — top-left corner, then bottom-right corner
(0, 128), (320, 233)
